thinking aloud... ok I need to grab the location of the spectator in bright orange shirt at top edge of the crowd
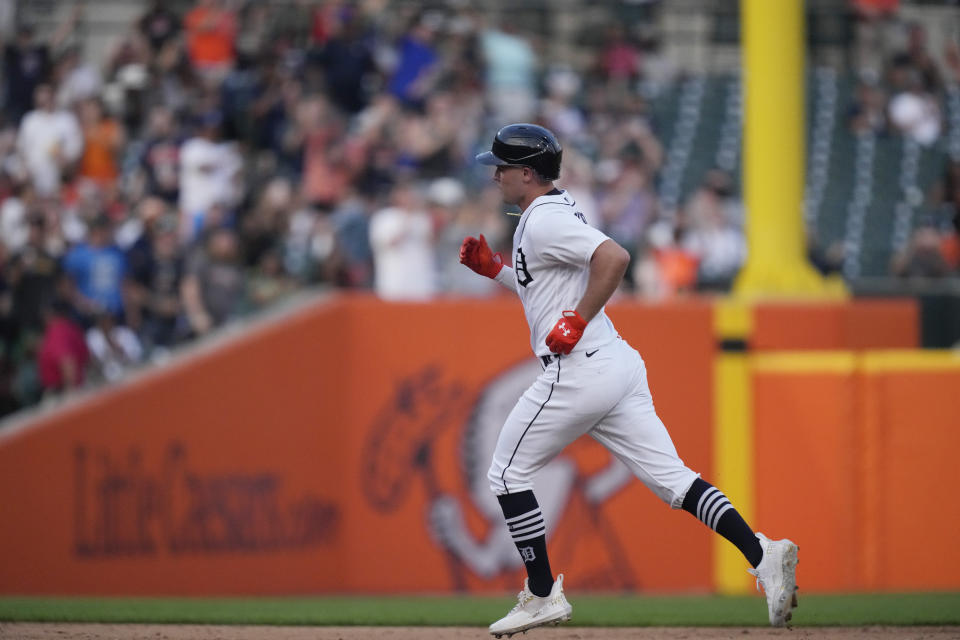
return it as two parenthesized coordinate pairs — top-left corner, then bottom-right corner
(184, 0), (237, 81)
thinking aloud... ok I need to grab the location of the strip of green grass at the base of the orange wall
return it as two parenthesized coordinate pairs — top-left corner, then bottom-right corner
(0, 593), (960, 626)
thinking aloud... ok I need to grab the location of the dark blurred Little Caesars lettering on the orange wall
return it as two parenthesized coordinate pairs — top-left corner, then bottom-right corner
(74, 442), (341, 557)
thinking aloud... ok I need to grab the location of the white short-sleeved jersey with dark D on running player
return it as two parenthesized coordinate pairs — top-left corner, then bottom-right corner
(497, 189), (617, 356)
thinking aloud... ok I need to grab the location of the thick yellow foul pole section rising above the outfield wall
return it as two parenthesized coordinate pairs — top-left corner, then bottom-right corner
(734, 0), (827, 297)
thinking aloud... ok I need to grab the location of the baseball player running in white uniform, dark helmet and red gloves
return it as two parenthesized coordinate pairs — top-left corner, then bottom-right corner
(460, 124), (797, 638)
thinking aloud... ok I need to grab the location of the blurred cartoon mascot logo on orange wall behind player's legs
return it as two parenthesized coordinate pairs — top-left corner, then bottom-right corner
(359, 358), (639, 591)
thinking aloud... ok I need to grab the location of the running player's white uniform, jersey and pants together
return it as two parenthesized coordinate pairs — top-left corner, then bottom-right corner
(487, 190), (698, 509)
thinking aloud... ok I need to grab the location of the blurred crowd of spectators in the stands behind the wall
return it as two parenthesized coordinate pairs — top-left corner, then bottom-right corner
(0, 0), (960, 415)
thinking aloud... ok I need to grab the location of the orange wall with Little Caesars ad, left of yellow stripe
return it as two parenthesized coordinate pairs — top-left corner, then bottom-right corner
(0, 296), (714, 595)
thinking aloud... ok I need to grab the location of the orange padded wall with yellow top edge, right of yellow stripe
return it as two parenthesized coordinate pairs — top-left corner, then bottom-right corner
(751, 351), (960, 590)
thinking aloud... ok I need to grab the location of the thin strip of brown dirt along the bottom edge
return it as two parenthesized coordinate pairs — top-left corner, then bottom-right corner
(0, 623), (960, 640)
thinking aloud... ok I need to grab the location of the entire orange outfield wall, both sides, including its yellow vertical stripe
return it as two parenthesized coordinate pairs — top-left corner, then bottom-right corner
(0, 296), (960, 595)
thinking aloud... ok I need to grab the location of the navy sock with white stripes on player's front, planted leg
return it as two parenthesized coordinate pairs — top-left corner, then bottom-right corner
(497, 491), (553, 598)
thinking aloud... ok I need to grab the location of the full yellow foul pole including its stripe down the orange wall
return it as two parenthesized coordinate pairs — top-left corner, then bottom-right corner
(713, 0), (843, 594)
